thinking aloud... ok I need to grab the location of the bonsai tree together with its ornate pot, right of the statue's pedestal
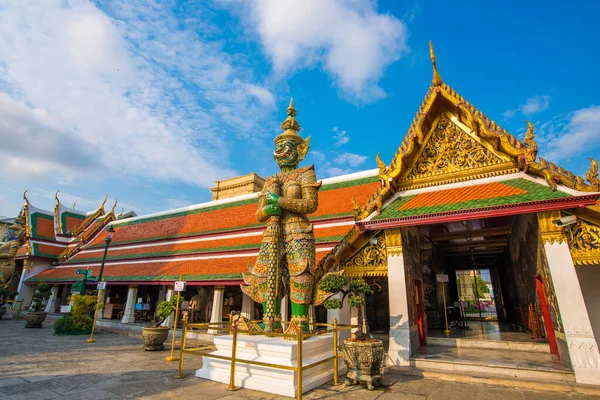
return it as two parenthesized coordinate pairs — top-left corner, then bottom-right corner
(318, 274), (385, 390)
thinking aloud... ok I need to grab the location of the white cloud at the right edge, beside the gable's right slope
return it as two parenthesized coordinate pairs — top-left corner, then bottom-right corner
(538, 106), (600, 162)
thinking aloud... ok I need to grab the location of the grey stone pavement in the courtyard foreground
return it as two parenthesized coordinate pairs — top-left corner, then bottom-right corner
(0, 320), (600, 400)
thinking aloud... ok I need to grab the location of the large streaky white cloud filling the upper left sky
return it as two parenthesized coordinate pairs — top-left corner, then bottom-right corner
(0, 0), (274, 187)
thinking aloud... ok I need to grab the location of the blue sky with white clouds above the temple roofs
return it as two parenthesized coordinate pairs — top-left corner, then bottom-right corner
(0, 0), (600, 219)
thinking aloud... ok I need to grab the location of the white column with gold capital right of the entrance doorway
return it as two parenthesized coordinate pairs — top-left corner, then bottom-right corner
(538, 212), (600, 385)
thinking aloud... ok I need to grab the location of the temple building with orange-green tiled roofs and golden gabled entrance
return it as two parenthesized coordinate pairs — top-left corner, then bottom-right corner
(9, 43), (600, 385)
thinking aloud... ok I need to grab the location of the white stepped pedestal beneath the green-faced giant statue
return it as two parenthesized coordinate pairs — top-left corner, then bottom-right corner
(196, 334), (346, 397)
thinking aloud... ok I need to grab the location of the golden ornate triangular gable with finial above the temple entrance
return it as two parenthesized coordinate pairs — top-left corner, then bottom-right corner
(354, 43), (600, 220)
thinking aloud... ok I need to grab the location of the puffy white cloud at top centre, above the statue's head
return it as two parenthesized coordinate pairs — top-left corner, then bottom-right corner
(224, 0), (409, 102)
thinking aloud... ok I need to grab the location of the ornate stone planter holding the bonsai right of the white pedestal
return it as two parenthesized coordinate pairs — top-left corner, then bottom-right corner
(343, 339), (385, 390)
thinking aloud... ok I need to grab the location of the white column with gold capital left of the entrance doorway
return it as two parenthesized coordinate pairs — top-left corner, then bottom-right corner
(379, 229), (410, 365)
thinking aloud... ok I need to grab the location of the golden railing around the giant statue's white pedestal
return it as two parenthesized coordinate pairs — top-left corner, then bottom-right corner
(177, 317), (358, 400)
